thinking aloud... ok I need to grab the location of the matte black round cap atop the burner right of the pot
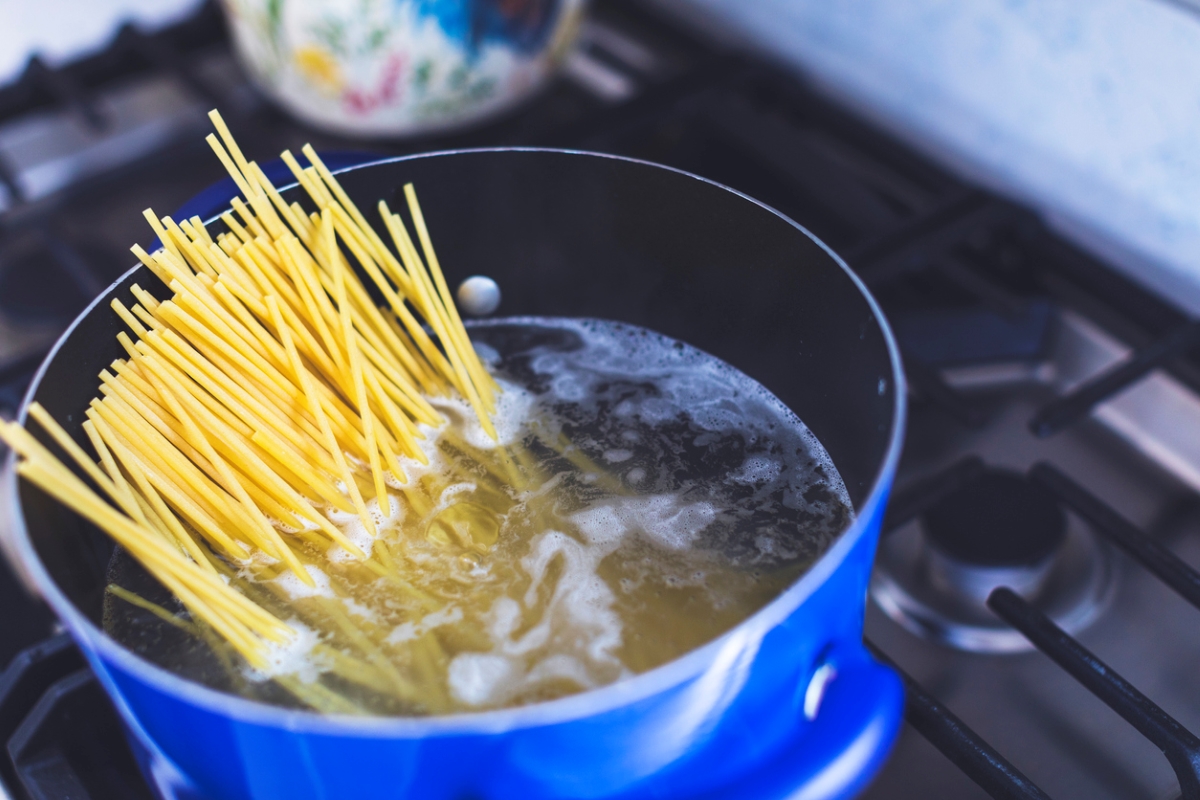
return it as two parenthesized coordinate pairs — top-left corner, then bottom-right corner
(923, 469), (1067, 567)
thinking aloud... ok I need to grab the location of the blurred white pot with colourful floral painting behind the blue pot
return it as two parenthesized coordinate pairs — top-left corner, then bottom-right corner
(223, 0), (586, 137)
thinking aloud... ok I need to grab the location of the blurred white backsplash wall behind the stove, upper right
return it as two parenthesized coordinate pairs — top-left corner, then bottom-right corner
(660, 0), (1200, 313)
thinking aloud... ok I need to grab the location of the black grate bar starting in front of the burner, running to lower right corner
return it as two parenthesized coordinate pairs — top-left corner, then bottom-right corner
(988, 588), (1200, 800)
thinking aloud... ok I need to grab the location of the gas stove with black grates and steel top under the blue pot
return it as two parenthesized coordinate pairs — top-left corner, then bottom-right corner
(0, 0), (1200, 800)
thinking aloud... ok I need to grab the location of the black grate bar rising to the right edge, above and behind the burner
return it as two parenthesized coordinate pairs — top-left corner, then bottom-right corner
(1030, 320), (1200, 438)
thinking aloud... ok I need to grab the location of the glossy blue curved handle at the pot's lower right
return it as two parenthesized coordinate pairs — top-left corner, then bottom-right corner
(696, 644), (904, 800)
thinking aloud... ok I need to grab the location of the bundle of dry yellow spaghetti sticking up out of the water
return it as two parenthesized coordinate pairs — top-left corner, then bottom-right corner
(0, 110), (498, 680)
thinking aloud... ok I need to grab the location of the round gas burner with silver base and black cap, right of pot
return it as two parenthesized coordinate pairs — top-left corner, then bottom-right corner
(871, 469), (1112, 652)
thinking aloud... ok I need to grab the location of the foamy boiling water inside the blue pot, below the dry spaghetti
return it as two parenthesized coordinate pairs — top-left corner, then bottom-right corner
(104, 319), (851, 714)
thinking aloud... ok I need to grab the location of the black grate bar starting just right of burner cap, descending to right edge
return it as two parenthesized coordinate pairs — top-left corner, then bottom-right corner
(1030, 462), (1200, 608)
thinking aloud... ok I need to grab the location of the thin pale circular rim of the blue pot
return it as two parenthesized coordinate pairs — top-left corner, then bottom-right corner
(0, 148), (907, 738)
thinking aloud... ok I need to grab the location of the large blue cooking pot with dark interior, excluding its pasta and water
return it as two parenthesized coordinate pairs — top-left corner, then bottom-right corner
(4, 150), (905, 800)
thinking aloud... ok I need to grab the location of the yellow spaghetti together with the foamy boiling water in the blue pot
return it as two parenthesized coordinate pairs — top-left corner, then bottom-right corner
(7, 112), (851, 715)
